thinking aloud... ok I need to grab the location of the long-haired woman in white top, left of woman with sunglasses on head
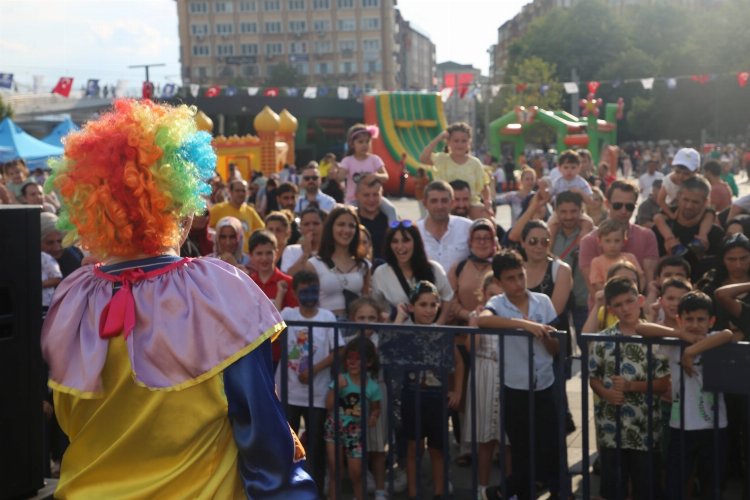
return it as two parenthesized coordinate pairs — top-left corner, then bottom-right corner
(305, 205), (370, 318)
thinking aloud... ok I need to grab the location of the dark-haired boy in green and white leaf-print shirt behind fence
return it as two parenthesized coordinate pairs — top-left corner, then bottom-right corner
(589, 276), (669, 499)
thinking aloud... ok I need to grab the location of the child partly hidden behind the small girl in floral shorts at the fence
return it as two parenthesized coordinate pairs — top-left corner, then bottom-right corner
(349, 297), (388, 500)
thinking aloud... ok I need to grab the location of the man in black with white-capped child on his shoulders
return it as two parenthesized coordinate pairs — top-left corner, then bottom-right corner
(653, 176), (724, 283)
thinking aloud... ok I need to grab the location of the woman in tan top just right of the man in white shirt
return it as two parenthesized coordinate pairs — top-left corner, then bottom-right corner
(448, 219), (499, 325)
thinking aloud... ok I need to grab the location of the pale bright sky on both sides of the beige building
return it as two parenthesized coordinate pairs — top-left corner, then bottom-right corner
(0, 0), (530, 89)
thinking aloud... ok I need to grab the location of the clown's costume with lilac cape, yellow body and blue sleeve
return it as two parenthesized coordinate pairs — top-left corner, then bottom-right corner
(42, 256), (317, 499)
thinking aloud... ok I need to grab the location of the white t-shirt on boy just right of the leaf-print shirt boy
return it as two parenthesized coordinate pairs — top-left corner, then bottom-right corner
(661, 338), (727, 431)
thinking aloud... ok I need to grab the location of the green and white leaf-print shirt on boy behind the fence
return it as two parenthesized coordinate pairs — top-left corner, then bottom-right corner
(589, 323), (669, 451)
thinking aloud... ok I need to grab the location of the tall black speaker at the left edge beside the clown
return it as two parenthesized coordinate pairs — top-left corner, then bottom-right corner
(0, 205), (45, 499)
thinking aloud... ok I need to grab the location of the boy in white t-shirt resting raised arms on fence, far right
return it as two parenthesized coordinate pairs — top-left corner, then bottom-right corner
(636, 291), (735, 500)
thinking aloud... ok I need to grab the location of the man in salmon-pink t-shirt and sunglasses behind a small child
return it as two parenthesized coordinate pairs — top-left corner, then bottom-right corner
(578, 179), (659, 299)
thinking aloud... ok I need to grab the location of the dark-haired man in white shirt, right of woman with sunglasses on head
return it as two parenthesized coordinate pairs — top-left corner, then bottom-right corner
(417, 181), (471, 270)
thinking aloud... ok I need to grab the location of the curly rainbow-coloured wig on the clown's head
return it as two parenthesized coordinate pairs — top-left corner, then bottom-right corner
(46, 100), (216, 259)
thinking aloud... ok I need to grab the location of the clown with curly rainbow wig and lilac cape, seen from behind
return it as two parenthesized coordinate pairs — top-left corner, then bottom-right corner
(42, 100), (316, 499)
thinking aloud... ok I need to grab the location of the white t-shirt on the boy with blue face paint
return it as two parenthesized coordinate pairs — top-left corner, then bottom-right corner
(276, 307), (344, 408)
